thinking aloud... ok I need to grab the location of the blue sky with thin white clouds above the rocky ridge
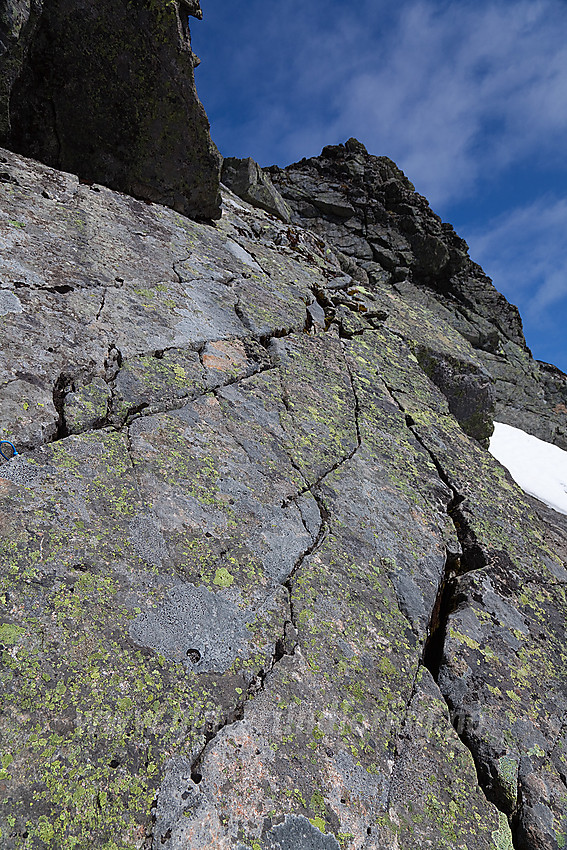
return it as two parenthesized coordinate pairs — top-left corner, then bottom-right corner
(191, 0), (567, 372)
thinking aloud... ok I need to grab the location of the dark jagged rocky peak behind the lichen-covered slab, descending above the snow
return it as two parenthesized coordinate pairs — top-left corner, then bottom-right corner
(268, 139), (567, 448)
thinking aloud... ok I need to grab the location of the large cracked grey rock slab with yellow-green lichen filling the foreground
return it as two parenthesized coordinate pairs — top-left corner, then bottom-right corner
(0, 146), (567, 850)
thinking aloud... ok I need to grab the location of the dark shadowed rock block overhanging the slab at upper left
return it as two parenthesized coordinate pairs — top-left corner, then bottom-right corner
(0, 0), (221, 219)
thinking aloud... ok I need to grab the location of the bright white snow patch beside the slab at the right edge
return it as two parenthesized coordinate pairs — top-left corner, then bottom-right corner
(490, 422), (567, 514)
